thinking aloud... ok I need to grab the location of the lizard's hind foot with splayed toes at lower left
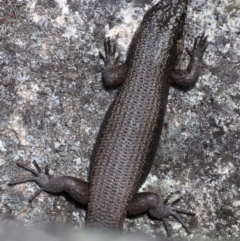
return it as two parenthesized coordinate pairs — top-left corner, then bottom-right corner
(8, 160), (51, 202)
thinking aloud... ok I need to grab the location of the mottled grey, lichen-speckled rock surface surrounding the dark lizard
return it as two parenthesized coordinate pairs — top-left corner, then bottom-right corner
(0, 0), (240, 240)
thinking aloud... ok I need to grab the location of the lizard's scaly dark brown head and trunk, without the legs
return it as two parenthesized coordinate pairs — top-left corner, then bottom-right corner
(87, 0), (187, 228)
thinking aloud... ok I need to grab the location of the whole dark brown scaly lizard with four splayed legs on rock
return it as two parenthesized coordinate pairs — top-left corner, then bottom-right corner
(10, 0), (207, 235)
